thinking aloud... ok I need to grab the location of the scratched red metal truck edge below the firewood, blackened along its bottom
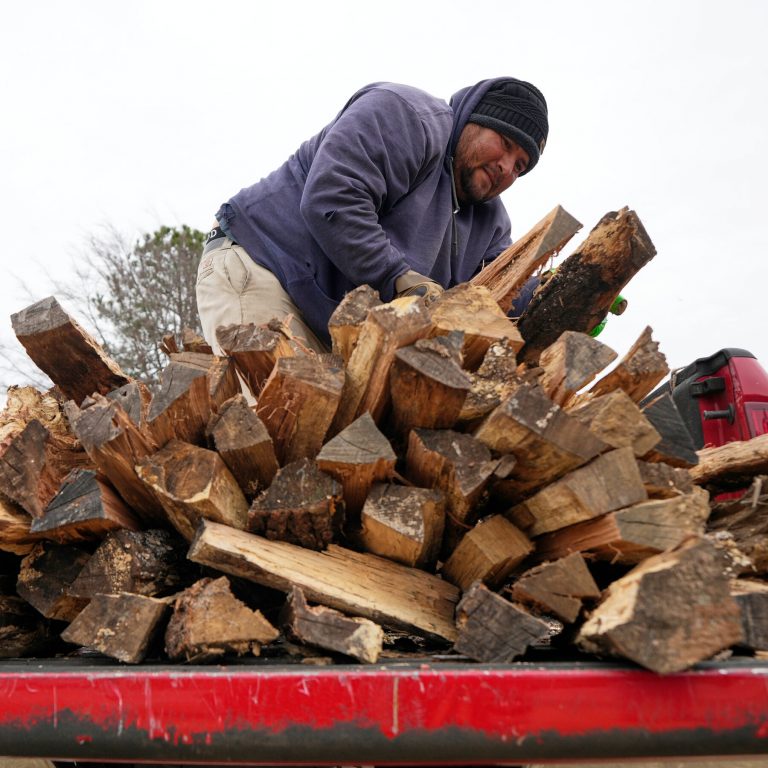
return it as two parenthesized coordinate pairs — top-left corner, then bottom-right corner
(0, 664), (768, 765)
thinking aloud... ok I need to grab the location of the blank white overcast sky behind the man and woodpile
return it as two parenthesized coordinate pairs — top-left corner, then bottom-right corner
(0, 0), (768, 390)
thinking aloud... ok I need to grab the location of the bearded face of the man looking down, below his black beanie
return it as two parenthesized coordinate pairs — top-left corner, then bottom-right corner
(453, 123), (530, 205)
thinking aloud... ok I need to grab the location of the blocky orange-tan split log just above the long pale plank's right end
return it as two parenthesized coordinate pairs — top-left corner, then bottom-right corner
(441, 515), (533, 590)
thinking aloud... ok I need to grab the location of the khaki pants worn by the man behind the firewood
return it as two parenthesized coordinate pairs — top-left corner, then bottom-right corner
(197, 237), (328, 355)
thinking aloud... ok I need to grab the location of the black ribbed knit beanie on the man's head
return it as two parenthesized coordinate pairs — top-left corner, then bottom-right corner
(469, 77), (549, 176)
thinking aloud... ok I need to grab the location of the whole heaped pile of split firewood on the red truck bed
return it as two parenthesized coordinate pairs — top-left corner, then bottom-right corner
(0, 208), (768, 672)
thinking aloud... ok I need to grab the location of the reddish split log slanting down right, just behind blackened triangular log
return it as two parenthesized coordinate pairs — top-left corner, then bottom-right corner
(66, 396), (165, 525)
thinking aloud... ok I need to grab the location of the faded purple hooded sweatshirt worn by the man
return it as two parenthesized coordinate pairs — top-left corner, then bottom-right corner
(216, 78), (510, 342)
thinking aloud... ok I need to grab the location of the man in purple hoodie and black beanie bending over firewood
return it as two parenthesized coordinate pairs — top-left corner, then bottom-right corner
(197, 77), (548, 352)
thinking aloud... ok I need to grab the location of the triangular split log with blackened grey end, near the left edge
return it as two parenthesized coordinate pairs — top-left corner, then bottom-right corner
(30, 469), (141, 544)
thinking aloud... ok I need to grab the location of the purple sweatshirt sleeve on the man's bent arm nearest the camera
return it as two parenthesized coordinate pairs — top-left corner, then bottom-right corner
(301, 89), (450, 301)
